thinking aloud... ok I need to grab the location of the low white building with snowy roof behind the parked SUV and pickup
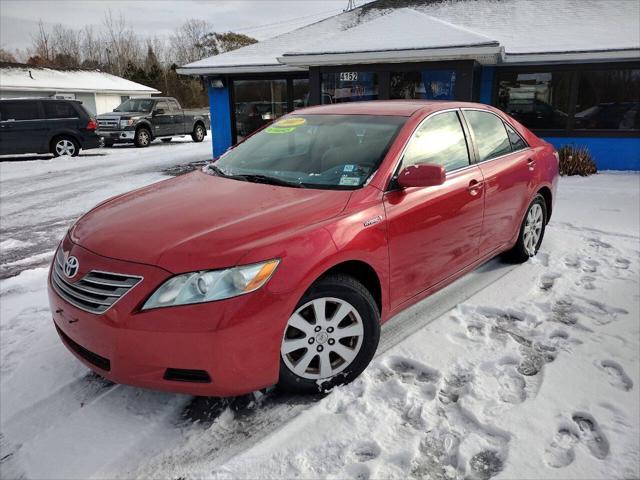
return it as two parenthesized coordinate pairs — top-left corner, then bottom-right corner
(0, 64), (160, 115)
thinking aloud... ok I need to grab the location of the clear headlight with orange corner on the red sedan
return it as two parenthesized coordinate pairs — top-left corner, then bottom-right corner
(142, 259), (280, 310)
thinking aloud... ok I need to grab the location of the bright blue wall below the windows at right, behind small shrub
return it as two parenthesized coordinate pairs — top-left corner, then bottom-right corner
(544, 137), (640, 170)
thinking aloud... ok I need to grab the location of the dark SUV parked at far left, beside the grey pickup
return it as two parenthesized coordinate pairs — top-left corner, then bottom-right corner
(0, 98), (100, 157)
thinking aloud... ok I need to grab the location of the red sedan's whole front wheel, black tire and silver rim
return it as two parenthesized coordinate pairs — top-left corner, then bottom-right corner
(278, 275), (380, 393)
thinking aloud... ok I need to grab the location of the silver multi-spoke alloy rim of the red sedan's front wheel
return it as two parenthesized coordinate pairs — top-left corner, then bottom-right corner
(280, 297), (364, 380)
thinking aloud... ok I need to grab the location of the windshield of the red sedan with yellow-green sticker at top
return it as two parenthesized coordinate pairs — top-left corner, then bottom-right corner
(213, 115), (406, 189)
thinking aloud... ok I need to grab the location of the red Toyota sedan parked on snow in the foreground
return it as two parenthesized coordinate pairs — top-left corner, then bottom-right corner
(49, 101), (558, 396)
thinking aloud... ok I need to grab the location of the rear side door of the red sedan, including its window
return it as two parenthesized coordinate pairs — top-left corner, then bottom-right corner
(463, 109), (536, 255)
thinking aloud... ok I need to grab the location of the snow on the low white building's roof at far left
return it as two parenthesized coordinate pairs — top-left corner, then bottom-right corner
(0, 65), (160, 94)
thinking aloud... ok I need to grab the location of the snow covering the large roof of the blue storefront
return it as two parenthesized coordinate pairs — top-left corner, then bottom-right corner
(179, 0), (640, 74)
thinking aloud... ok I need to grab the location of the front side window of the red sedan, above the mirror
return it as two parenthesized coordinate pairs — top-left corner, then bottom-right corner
(402, 112), (469, 171)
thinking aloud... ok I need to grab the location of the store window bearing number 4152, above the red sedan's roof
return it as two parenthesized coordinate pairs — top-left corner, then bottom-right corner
(321, 71), (379, 104)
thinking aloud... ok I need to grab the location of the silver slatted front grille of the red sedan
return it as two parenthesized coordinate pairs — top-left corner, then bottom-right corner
(51, 248), (142, 314)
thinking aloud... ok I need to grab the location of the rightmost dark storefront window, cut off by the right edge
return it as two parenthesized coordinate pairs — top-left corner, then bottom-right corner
(574, 69), (640, 130)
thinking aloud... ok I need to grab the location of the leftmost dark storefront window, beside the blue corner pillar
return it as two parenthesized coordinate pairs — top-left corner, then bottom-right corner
(233, 79), (288, 140)
